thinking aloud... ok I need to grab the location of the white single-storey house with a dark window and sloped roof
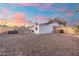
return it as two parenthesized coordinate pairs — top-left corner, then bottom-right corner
(29, 22), (60, 34)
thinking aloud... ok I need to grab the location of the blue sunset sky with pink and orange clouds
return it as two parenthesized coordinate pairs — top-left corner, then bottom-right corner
(0, 3), (79, 24)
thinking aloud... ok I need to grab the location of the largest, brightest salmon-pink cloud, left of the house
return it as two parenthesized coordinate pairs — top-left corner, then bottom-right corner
(12, 13), (25, 24)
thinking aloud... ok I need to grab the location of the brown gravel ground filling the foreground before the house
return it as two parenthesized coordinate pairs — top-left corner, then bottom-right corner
(0, 32), (79, 56)
